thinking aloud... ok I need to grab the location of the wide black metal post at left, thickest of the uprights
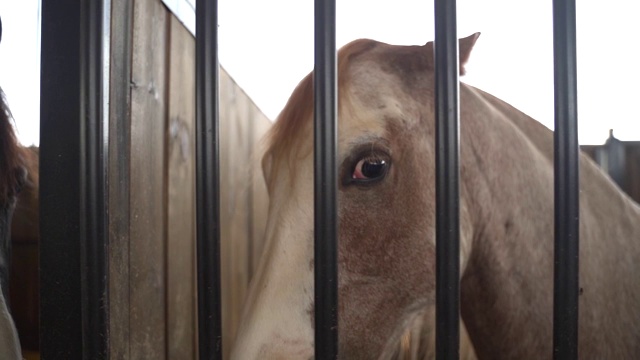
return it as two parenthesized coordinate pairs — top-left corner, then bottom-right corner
(40, 0), (108, 359)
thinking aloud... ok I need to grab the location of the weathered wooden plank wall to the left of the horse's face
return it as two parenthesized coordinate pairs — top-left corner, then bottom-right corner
(110, 0), (270, 359)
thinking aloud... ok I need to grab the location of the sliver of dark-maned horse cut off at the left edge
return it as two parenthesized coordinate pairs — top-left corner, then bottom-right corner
(0, 85), (26, 360)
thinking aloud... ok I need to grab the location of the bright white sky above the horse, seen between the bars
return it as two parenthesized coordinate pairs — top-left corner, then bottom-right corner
(0, 0), (640, 144)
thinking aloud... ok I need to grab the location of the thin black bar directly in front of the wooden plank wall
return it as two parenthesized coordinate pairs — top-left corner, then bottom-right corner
(196, 0), (222, 359)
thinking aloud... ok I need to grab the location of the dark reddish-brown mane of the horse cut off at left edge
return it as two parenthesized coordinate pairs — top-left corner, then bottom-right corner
(0, 89), (24, 203)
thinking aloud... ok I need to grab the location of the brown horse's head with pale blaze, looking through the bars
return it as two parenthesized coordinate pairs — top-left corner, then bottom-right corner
(232, 34), (479, 359)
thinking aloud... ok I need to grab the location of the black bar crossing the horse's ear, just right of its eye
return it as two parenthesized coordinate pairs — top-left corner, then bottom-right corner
(435, 0), (460, 360)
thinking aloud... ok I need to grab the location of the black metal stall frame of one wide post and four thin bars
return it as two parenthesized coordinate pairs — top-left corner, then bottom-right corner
(40, 0), (579, 359)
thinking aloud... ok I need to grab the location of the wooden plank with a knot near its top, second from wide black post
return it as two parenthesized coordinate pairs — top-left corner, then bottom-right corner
(129, 0), (168, 359)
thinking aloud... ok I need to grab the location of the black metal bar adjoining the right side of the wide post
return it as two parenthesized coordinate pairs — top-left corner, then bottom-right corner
(79, 0), (108, 359)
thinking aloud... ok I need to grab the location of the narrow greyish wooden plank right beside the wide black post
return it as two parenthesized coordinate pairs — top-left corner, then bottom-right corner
(108, 0), (133, 359)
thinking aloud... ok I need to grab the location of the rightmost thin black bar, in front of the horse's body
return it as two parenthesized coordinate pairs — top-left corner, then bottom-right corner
(553, 0), (580, 360)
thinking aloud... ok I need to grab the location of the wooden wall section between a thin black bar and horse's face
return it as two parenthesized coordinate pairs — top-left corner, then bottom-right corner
(220, 69), (270, 358)
